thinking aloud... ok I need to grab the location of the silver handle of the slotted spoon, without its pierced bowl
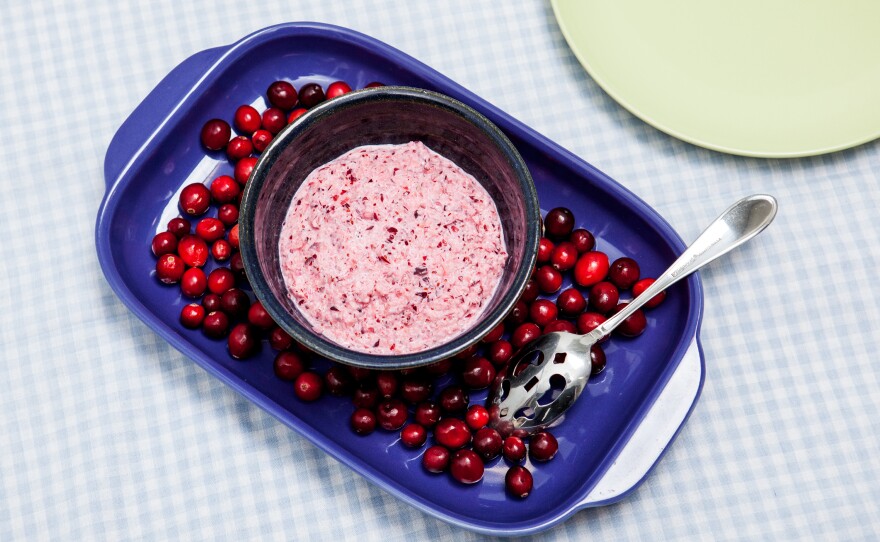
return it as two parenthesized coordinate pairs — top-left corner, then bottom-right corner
(585, 194), (777, 340)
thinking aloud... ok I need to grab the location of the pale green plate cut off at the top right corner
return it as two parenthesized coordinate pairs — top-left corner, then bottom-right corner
(551, 0), (880, 157)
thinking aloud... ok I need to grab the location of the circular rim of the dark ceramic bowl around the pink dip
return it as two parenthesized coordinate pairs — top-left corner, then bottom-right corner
(238, 86), (541, 369)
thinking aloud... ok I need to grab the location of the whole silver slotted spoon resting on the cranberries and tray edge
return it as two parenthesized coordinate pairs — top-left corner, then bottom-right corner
(489, 194), (777, 435)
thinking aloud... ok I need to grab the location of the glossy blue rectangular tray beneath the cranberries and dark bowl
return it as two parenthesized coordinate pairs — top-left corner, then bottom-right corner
(96, 23), (702, 535)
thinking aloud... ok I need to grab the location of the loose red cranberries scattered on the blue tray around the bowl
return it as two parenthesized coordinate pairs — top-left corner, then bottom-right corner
(151, 76), (665, 498)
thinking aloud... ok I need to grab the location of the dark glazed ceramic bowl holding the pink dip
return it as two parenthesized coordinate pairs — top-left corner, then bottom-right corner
(239, 87), (541, 369)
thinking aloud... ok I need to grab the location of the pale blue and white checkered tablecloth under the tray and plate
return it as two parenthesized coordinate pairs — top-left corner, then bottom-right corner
(0, 0), (880, 541)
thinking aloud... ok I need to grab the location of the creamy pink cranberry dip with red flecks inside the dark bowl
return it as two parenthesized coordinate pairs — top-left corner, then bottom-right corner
(279, 142), (507, 354)
